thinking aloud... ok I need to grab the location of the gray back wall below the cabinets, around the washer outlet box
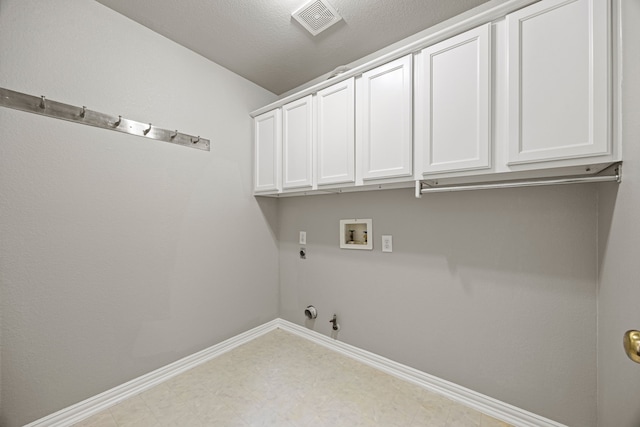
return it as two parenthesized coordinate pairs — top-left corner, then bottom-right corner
(279, 185), (597, 427)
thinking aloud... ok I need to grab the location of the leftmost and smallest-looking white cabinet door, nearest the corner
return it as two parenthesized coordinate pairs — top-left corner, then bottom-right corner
(253, 109), (282, 193)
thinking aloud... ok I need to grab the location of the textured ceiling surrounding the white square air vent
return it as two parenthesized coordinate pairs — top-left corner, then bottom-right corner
(97, 0), (488, 95)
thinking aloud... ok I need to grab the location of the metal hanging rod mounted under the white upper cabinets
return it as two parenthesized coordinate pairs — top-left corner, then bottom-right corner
(416, 164), (622, 199)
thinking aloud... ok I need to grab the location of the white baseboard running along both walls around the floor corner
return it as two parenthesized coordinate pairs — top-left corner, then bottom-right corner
(24, 319), (567, 427)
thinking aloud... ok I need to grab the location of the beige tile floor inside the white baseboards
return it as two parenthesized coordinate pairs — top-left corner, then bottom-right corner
(76, 330), (509, 427)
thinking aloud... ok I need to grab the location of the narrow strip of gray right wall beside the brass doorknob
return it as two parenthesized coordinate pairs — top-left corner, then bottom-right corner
(598, 0), (640, 427)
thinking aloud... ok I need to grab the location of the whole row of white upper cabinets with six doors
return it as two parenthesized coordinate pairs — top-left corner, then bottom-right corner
(249, 0), (622, 196)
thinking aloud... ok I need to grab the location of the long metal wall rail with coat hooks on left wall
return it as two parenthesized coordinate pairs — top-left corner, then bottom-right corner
(0, 87), (211, 151)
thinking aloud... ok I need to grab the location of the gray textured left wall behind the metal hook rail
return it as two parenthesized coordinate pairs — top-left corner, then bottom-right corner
(0, 0), (278, 427)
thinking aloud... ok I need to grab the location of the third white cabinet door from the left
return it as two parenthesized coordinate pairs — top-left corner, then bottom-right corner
(316, 78), (355, 185)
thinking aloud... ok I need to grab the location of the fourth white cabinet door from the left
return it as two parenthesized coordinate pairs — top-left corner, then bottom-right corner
(357, 55), (413, 180)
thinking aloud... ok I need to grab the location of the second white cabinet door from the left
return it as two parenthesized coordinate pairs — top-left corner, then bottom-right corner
(282, 95), (313, 189)
